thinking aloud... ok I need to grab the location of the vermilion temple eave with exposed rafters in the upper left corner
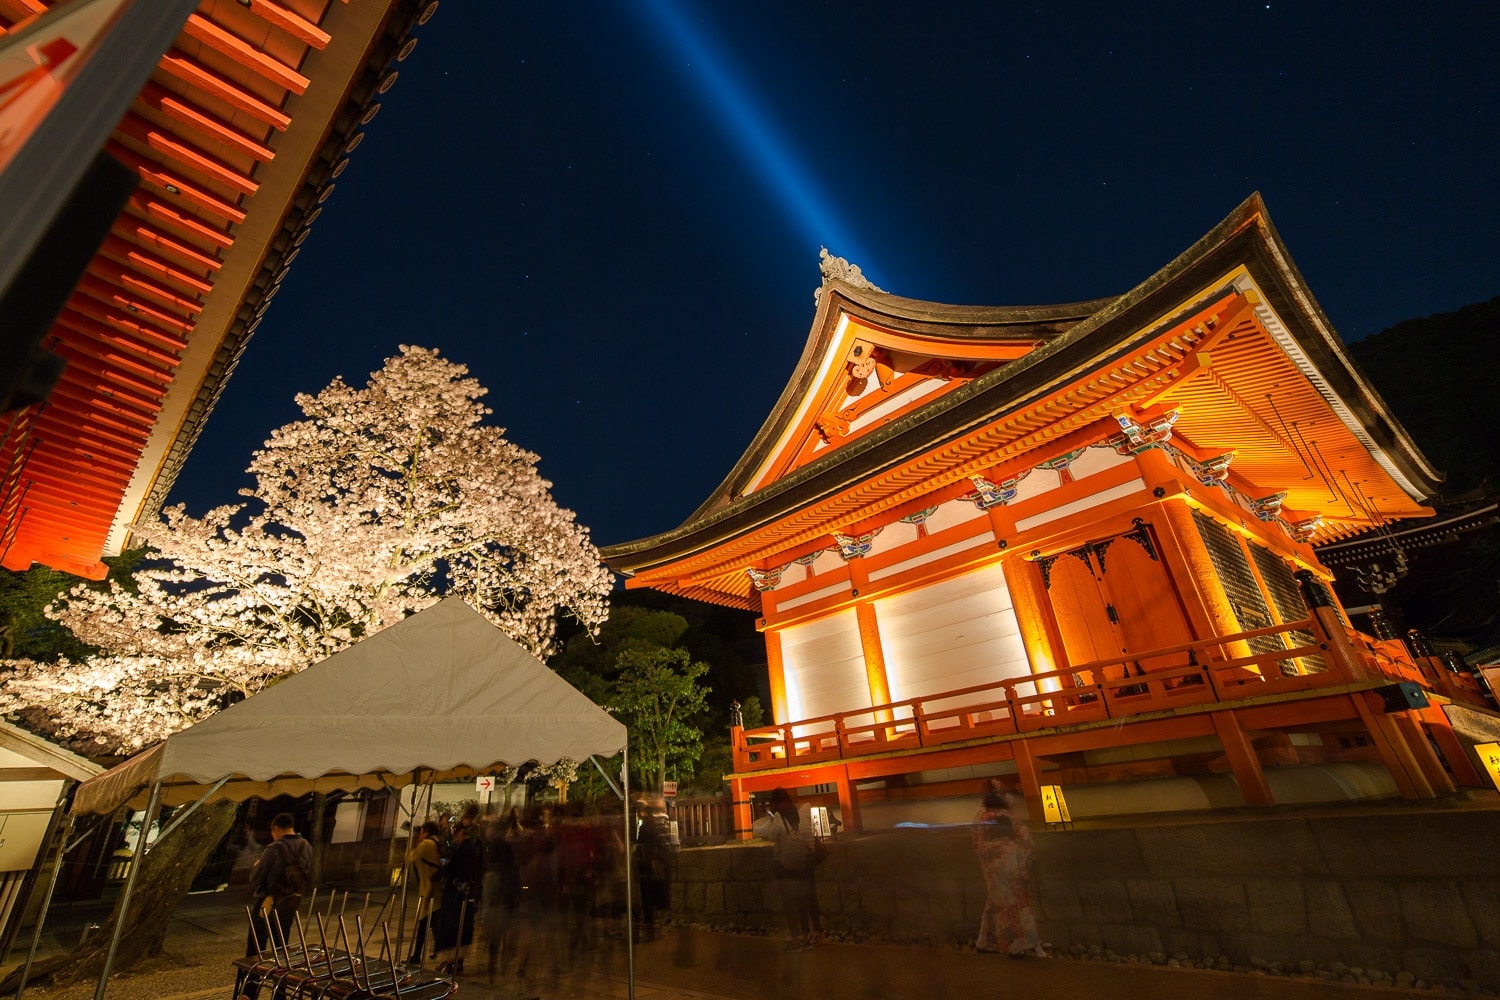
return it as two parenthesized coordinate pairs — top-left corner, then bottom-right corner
(0, 0), (438, 579)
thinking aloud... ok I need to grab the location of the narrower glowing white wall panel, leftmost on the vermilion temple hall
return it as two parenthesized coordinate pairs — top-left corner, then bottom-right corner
(782, 609), (870, 718)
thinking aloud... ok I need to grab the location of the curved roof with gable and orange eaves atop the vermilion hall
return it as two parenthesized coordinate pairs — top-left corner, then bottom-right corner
(603, 195), (1442, 607)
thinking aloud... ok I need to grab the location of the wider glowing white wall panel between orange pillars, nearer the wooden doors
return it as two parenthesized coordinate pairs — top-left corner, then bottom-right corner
(875, 564), (1031, 702)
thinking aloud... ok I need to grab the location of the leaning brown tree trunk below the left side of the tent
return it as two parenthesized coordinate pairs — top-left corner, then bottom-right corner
(0, 802), (236, 994)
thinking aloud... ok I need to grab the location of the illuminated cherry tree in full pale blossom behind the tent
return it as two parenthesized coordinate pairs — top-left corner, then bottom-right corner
(0, 346), (611, 756)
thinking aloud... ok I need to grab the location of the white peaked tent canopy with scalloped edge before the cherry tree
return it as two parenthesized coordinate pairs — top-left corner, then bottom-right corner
(72, 598), (626, 816)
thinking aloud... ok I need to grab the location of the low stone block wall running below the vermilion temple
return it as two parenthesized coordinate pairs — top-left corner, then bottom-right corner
(672, 808), (1500, 990)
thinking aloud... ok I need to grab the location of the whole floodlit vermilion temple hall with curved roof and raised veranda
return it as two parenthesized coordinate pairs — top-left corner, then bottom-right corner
(605, 196), (1484, 831)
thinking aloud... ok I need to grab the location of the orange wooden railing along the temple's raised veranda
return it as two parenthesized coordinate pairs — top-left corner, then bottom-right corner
(734, 618), (1482, 772)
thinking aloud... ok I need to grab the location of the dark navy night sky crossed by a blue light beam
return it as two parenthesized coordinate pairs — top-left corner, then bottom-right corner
(170, 0), (1500, 554)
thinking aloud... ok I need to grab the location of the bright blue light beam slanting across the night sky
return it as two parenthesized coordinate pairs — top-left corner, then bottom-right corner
(629, 0), (870, 273)
